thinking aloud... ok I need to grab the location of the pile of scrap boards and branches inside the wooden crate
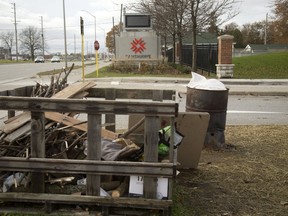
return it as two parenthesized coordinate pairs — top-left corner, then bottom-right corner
(0, 66), (141, 197)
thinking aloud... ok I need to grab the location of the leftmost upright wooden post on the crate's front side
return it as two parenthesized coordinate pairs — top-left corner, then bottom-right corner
(31, 112), (45, 193)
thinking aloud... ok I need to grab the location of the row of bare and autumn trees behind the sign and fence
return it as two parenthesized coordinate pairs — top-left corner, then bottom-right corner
(106, 0), (288, 71)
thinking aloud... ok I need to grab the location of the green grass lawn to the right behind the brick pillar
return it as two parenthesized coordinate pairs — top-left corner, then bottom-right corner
(233, 52), (288, 79)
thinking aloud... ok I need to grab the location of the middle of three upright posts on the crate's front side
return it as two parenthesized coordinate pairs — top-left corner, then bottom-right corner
(86, 114), (101, 196)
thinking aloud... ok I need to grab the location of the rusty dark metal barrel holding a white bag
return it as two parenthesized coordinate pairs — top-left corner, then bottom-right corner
(186, 87), (229, 149)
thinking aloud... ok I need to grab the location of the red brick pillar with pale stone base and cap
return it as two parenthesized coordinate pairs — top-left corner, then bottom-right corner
(216, 35), (234, 78)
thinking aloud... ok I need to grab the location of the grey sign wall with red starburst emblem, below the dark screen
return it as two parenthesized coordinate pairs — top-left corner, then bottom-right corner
(116, 32), (161, 60)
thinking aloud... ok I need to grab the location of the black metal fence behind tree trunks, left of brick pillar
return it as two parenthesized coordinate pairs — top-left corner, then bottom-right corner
(167, 44), (218, 73)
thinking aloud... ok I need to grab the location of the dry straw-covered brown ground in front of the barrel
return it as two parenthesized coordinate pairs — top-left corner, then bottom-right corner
(173, 125), (288, 216)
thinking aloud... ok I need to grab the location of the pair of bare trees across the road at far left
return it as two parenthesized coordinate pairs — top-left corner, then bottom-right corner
(0, 26), (47, 60)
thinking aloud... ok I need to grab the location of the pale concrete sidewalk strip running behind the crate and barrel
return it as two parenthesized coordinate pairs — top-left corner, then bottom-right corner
(0, 65), (288, 96)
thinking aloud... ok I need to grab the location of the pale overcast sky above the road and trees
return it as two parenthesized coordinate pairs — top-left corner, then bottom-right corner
(0, 0), (273, 53)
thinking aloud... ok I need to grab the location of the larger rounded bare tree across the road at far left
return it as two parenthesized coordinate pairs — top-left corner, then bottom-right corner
(19, 26), (43, 60)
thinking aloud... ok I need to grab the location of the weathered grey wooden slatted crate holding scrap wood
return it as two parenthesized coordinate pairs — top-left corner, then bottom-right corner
(0, 89), (178, 215)
